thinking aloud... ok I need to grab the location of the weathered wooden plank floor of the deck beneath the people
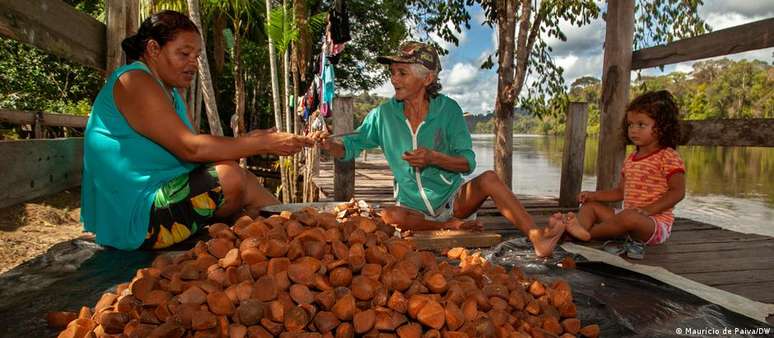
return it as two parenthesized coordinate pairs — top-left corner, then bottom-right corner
(315, 160), (774, 323)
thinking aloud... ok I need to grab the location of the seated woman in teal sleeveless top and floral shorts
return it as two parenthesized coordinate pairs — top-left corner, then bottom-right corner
(81, 11), (313, 250)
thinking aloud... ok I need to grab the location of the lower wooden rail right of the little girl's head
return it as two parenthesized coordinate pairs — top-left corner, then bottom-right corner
(680, 119), (774, 147)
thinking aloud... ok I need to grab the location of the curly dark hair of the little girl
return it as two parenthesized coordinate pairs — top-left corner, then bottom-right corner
(623, 90), (680, 149)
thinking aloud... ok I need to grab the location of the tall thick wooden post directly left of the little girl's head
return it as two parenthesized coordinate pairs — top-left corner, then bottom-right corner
(597, 0), (634, 190)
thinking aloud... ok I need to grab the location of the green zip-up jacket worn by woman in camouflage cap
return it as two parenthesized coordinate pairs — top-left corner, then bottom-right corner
(343, 95), (476, 216)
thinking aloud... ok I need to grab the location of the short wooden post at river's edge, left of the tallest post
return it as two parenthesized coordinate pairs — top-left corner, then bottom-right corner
(559, 102), (589, 208)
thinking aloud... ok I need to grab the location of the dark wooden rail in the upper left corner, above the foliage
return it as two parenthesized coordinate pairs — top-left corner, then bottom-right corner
(0, 0), (106, 71)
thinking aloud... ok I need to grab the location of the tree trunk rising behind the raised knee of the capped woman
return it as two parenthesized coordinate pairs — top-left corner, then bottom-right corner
(494, 1), (516, 188)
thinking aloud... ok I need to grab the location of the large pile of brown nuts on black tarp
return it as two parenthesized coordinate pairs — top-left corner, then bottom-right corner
(53, 208), (599, 338)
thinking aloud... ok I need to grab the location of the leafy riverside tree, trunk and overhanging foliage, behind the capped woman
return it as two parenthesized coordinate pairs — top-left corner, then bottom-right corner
(414, 0), (709, 186)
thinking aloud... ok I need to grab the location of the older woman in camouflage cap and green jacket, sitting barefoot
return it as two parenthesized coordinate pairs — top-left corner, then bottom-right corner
(312, 41), (564, 257)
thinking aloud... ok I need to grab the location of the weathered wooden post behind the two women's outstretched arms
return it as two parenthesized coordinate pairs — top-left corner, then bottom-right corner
(333, 97), (355, 201)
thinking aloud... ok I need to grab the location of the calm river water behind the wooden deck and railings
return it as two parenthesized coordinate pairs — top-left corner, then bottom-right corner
(473, 134), (774, 236)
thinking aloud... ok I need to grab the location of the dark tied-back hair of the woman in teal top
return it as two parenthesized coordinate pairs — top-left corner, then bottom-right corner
(121, 11), (199, 62)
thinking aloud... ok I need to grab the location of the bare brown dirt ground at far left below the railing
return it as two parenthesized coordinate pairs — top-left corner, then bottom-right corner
(0, 188), (84, 273)
